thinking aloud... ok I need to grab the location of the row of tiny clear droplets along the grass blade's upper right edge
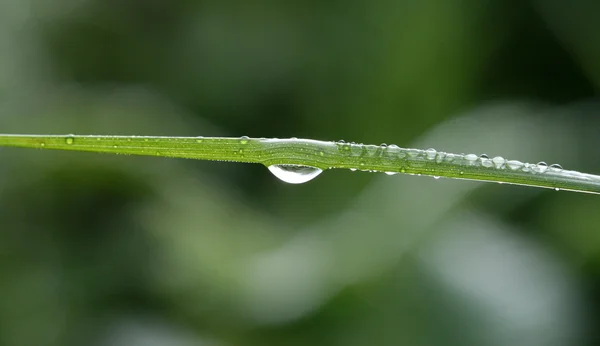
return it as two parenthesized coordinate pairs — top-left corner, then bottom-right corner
(336, 141), (563, 174)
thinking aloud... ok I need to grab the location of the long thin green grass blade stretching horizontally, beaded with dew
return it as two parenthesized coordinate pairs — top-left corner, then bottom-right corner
(0, 134), (600, 194)
